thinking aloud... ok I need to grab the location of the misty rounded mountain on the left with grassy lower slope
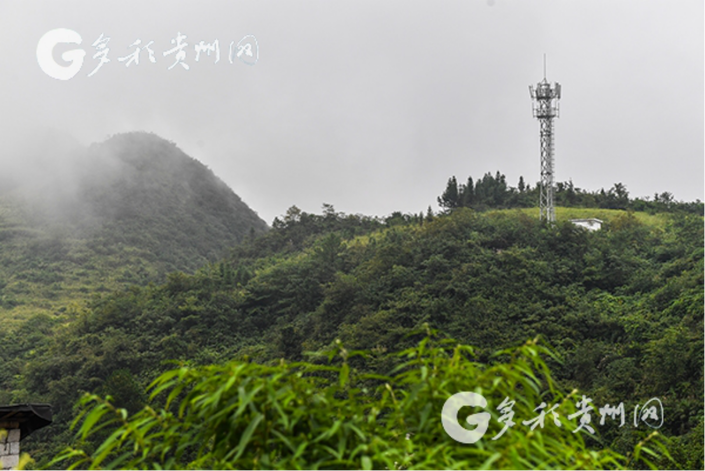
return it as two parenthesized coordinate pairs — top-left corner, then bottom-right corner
(0, 133), (267, 329)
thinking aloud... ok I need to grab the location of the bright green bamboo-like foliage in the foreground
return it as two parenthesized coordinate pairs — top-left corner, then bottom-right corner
(41, 332), (668, 470)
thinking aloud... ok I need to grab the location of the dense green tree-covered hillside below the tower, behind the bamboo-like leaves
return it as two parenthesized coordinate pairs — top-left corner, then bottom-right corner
(5, 202), (705, 469)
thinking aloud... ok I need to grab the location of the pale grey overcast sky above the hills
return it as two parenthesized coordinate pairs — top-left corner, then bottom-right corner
(0, 0), (705, 223)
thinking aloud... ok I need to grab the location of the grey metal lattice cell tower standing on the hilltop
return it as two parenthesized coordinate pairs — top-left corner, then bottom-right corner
(529, 54), (561, 222)
